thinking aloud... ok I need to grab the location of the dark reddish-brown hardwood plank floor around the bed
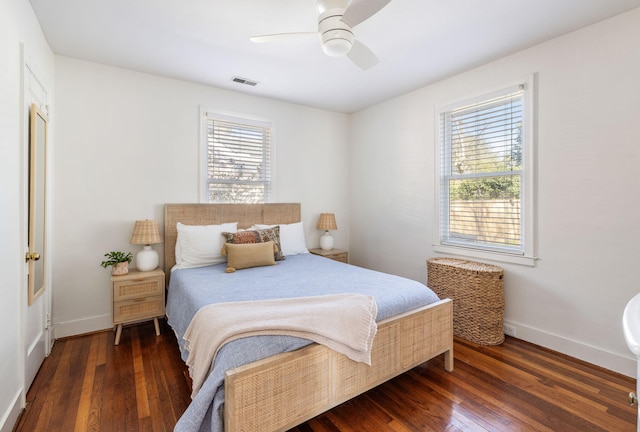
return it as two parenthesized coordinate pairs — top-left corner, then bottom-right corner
(14, 320), (637, 432)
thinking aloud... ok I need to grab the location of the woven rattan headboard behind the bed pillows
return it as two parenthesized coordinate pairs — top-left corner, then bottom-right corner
(164, 203), (301, 279)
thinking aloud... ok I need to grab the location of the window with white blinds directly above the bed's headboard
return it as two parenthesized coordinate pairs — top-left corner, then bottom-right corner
(203, 113), (271, 203)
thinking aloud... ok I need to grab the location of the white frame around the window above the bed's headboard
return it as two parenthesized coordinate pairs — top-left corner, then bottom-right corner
(198, 106), (275, 204)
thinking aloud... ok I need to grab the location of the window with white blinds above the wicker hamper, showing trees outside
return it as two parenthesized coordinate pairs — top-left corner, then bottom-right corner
(436, 82), (533, 264)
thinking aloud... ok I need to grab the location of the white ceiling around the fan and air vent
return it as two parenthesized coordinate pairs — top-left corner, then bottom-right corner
(31, 0), (640, 113)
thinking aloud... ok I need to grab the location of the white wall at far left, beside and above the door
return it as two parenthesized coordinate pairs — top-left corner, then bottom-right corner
(0, 0), (53, 432)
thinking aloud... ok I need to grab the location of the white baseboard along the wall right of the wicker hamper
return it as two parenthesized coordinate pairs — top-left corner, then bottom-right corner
(504, 321), (637, 378)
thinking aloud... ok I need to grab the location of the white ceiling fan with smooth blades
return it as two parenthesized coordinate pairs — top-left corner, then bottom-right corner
(250, 0), (391, 70)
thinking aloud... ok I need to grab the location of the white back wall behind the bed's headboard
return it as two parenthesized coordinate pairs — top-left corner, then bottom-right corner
(53, 57), (350, 337)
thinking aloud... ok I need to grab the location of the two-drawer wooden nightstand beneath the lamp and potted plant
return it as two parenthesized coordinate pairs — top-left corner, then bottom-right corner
(111, 268), (164, 345)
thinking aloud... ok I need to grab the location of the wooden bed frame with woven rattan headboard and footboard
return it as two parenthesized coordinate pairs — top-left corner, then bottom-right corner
(164, 203), (453, 432)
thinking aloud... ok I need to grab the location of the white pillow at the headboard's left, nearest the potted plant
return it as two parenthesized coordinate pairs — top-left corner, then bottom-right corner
(176, 222), (238, 268)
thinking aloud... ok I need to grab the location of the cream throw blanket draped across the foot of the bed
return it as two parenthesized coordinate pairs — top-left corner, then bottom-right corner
(184, 294), (378, 398)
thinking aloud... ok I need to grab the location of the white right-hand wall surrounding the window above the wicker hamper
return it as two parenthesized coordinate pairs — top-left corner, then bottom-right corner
(350, 9), (640, 376)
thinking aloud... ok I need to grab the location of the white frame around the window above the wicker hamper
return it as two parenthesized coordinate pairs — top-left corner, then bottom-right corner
(433, 75), (537, 267)
